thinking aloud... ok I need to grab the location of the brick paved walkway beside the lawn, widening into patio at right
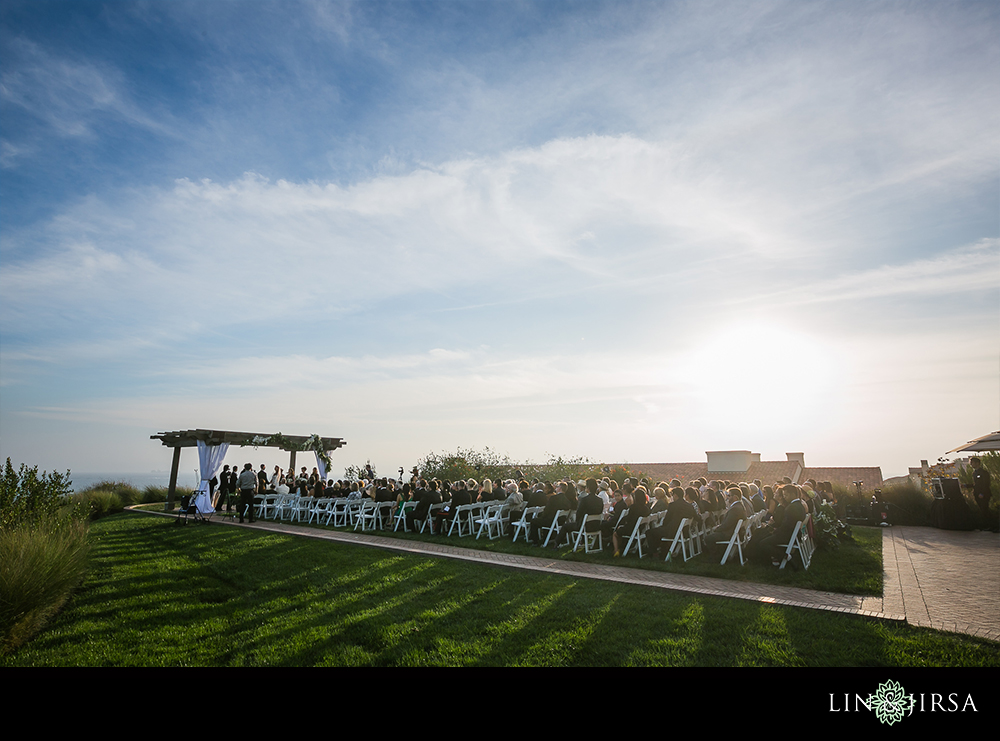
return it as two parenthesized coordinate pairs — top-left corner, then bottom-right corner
(150, 515), (1000, 641)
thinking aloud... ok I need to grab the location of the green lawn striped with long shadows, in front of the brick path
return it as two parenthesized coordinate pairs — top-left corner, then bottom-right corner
(0, 513), (1000, 666)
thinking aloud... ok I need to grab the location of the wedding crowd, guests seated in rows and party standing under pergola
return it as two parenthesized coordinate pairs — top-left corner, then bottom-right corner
(209, 463), (833, 562)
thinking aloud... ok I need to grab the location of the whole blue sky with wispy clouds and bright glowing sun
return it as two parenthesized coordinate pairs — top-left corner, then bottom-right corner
(0, 0), (1000, 476)
